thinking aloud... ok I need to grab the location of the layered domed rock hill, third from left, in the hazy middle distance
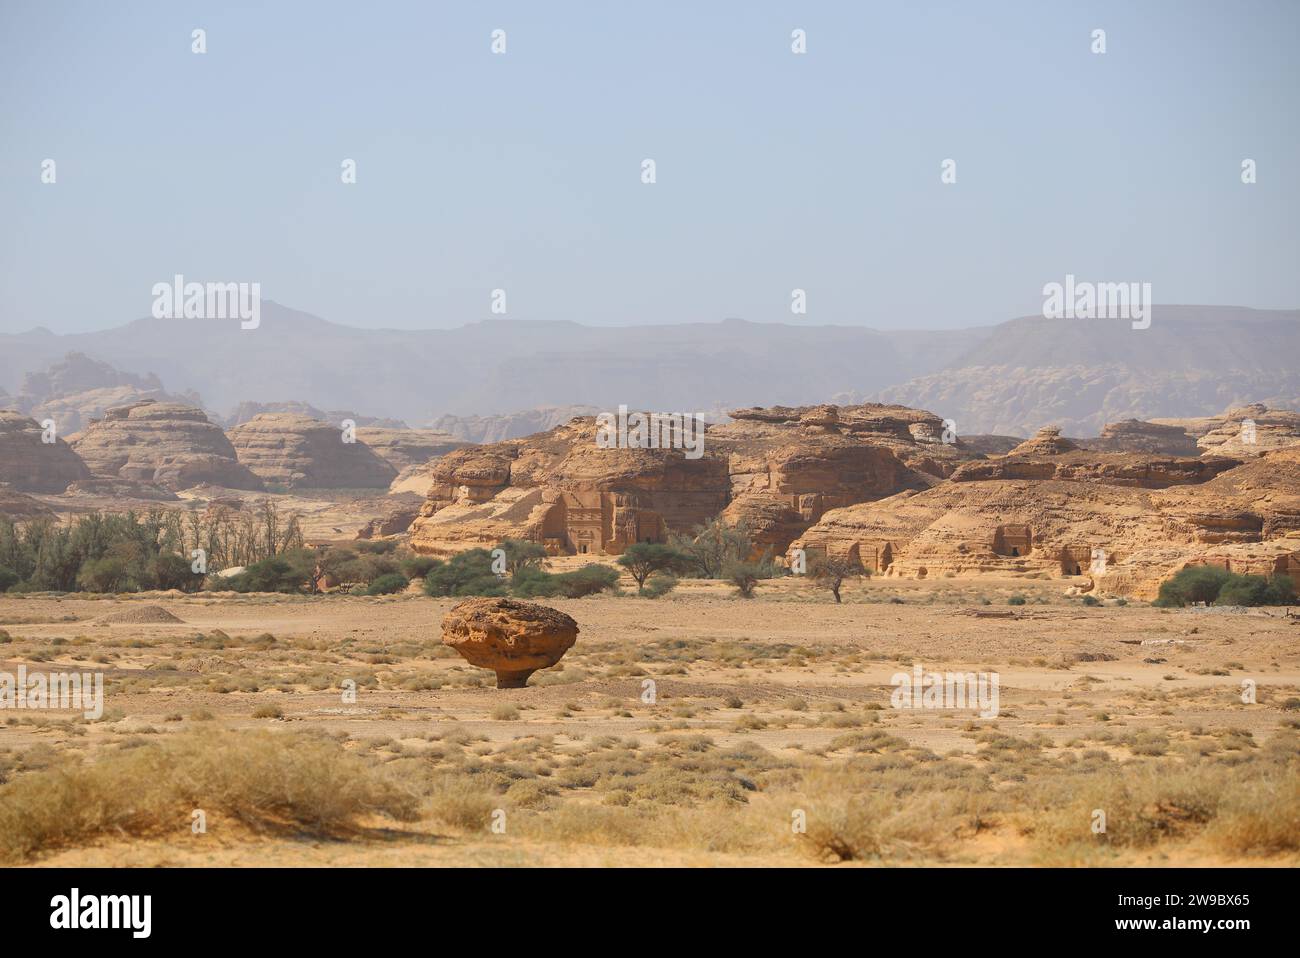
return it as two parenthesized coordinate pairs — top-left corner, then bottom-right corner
(229, 413), (398, 489)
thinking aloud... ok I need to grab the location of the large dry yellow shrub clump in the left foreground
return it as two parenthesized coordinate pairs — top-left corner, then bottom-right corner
(0, 729), (419, 861)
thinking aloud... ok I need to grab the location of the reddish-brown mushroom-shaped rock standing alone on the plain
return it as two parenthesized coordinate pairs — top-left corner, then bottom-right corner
(442, 598), (577, 689)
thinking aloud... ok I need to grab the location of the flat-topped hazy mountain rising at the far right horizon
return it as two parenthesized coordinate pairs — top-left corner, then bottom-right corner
(879, 305), (1300, 435)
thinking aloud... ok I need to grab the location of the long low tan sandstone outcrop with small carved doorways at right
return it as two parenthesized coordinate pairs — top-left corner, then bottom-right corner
(790, 447), (1300, 598)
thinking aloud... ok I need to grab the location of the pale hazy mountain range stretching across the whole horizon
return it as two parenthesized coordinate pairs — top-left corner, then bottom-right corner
(0, 302), (1300, 438)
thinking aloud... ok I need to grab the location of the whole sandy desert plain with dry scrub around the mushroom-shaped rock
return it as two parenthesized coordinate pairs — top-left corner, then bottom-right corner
(0, 558), (1300, 867)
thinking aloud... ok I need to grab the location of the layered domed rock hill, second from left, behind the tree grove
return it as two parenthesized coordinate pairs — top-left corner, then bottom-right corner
(72, 399), (263, 491)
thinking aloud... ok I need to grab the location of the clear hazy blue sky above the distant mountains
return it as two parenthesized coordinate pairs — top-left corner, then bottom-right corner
(0, 0), (1300, 333)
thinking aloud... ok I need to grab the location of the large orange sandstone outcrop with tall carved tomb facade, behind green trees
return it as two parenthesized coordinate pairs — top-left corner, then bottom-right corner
(411, 404), (974, 555)
